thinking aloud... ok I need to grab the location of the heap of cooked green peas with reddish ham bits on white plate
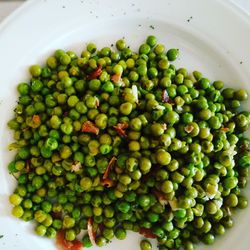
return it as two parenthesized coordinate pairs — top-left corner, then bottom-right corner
(8, 35), (250, 250)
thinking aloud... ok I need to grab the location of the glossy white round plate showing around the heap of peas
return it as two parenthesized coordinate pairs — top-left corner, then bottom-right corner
(0, 0), (250, 250)
